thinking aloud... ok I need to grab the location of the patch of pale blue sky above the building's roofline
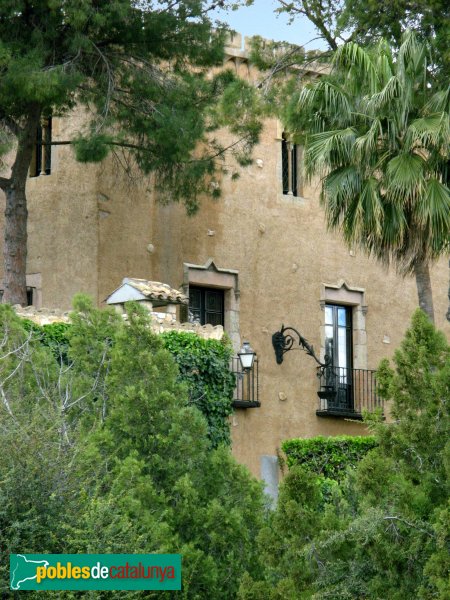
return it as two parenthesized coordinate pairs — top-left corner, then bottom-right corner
(211, 0), (326, 50)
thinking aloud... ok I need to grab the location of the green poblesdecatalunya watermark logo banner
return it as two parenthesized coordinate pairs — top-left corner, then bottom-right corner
(9, 554), (181, 591)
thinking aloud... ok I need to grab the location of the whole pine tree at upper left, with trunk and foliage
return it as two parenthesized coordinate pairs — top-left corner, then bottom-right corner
(0, 0), (260, 304)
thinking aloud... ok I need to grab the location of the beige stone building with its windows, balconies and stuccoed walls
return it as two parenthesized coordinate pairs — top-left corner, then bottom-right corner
(1, 36), (449, 486)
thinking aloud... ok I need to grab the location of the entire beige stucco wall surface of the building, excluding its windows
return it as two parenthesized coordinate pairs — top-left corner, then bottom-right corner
(1, 39), (450, 476)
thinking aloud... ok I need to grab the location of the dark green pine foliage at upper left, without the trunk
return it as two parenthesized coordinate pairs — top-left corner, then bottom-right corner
(0, 0), (258, 197)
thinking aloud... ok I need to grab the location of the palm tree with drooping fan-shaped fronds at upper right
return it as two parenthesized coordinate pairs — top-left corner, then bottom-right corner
(286, 32), (450, 321)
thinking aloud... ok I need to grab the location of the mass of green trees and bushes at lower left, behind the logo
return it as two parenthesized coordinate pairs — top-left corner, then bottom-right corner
(0, 298), (264, 598)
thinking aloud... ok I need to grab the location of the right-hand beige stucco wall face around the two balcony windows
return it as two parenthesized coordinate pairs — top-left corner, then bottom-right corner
(151, 115), (450, 475)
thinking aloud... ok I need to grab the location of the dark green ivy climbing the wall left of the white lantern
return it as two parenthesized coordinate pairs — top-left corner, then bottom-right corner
(161, 331), (236, 448)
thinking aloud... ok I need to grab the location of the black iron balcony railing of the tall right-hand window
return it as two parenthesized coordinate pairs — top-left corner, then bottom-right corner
(316, 366), (383, 419)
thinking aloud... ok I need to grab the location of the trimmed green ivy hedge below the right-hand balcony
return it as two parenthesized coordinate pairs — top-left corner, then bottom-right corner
(281, 435), (378, 481)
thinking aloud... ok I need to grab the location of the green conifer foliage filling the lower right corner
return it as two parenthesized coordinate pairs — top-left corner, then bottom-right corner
(239, 311), (450, 600)
